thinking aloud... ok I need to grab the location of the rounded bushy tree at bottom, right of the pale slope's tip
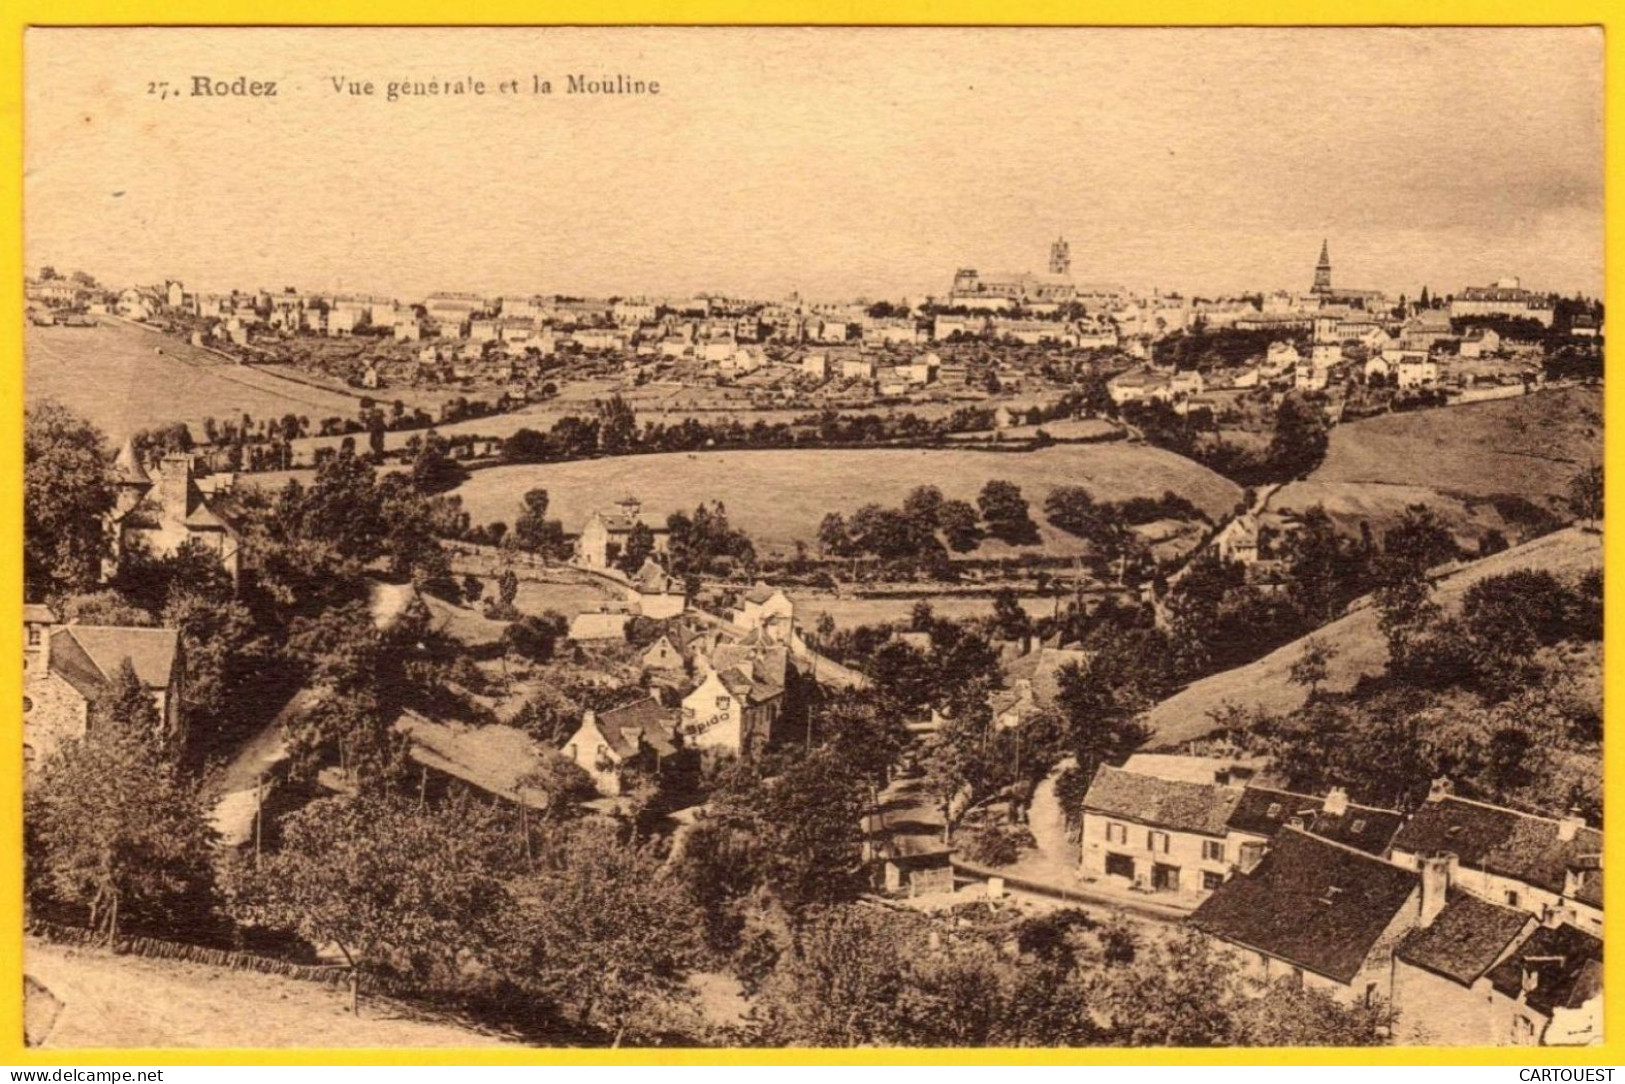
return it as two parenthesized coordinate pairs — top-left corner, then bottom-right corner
(501, 822), (702, 1047)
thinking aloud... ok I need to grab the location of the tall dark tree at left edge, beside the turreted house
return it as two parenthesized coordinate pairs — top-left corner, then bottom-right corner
(23, 400), (114, 598)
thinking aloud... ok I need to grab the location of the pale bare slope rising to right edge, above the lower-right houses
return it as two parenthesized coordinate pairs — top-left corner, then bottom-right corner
(1146, 527), (1602, 749)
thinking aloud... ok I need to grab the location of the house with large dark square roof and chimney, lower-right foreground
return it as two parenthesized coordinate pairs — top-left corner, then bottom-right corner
(1190, 826), (1423, 1004)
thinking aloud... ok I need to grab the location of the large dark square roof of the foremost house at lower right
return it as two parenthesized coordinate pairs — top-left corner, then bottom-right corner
(1191, 827), (1419, 983)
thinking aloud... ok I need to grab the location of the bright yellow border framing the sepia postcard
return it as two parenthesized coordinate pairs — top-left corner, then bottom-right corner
(0, 0), (1625, 1066)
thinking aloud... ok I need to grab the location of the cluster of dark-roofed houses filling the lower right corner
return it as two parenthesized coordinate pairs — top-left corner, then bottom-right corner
(1081, 756), (1602, 1045)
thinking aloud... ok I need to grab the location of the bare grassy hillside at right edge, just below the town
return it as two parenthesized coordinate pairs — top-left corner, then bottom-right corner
(1269, 387), (1602, 548)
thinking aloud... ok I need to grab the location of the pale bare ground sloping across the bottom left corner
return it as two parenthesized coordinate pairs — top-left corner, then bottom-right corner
(23, 938), (502, 1048)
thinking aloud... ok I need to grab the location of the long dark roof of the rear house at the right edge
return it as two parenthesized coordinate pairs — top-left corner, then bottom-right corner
(1394, 795), (1602, 894)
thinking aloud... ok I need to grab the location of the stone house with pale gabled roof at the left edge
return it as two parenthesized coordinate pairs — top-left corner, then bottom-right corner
(23, 605), (184, 769)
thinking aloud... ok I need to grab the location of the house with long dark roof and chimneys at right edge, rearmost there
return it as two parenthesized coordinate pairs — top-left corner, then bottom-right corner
(1393, 778), (1602, 936)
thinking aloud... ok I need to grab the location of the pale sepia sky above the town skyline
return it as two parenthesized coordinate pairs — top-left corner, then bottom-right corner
(24, 29), (1602, 299)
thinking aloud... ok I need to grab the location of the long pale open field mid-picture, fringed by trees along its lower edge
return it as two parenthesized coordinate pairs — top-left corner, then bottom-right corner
(438, 444), (1242, 556)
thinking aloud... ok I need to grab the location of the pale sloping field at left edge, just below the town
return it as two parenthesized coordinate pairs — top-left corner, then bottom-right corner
(23, 317), (356, 444)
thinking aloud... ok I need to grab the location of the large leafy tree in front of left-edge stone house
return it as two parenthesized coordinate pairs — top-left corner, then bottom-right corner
(26, 724), (215, 943)
